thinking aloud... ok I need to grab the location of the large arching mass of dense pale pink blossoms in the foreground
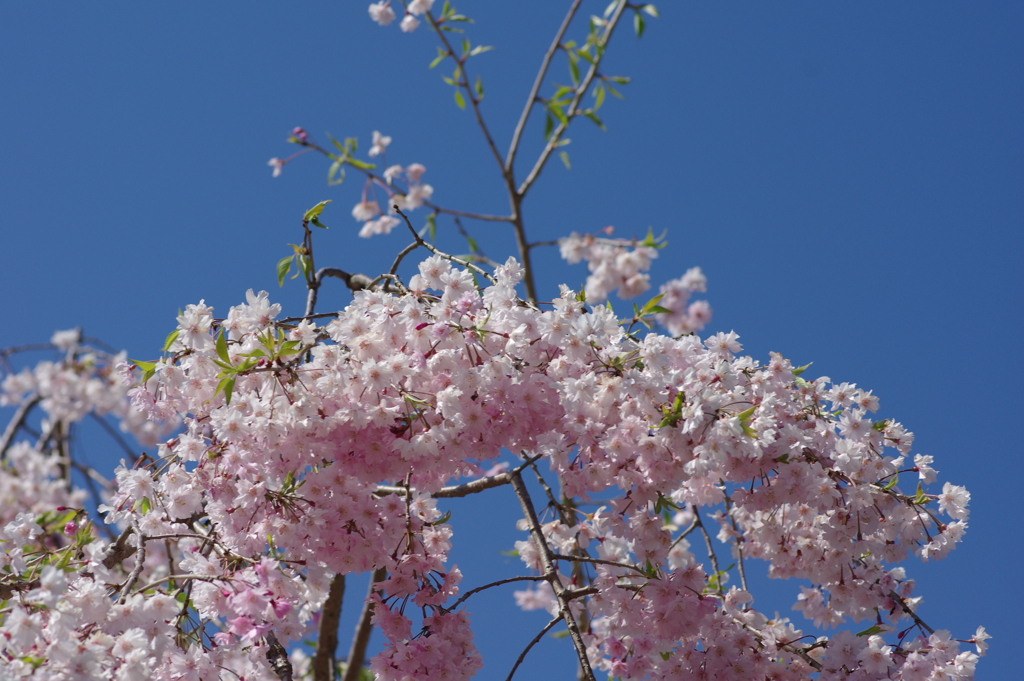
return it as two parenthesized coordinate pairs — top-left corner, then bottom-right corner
(0, 256), (986, 680)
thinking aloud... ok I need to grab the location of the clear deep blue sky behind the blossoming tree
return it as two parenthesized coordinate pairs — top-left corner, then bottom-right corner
(0, 0), (1024, 678)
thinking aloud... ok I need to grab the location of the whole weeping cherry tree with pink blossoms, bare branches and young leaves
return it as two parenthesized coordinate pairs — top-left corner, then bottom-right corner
(0, 0), (988, 681)
